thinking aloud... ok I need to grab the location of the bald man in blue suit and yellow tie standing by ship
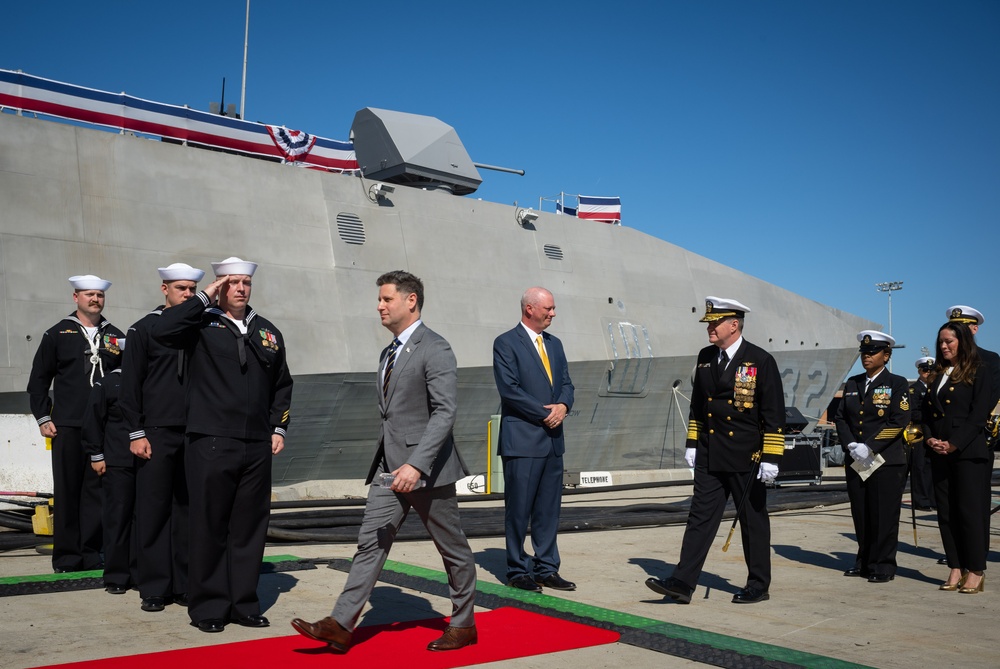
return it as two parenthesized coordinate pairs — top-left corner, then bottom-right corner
(493, 288), (576, 592)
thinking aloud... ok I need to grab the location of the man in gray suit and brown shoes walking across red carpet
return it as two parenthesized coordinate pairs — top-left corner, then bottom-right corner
(292, 271), (477, 653)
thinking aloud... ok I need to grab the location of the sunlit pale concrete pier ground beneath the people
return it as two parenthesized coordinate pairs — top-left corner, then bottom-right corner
(0, 478), (1000, 669)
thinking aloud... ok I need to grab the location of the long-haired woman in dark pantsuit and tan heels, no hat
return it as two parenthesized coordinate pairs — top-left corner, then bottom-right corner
(923, 323), (993, 594)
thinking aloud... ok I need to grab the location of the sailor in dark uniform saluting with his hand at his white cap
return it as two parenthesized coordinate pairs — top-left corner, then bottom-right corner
(153, 258), (292, 632)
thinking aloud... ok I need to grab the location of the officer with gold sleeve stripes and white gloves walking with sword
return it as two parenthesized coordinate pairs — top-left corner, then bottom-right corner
(646, 296), (785, 604)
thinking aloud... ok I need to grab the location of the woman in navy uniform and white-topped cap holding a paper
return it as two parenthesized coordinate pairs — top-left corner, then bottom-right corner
(834, 330), (910, 583)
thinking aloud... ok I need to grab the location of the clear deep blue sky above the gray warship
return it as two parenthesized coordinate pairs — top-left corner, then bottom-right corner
(0, 0), (1000, 376)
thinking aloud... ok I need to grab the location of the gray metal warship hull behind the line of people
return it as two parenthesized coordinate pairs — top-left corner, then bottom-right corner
(0, 107), (874, 485)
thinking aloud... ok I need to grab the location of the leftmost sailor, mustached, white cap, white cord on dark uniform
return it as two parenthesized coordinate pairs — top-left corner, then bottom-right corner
(28, 274), (125, 573)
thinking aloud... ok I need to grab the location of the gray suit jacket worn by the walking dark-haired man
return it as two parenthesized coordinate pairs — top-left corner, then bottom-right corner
(365, 323), (469, 488)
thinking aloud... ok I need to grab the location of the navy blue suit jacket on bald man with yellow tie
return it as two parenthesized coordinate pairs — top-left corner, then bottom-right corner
(493, 323), (573, 458)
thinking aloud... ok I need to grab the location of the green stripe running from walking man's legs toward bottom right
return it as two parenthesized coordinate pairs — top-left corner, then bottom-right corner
(385, 560), (870, 669)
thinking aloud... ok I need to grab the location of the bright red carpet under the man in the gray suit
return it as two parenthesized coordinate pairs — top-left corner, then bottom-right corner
(31, 607), (618, 669)
